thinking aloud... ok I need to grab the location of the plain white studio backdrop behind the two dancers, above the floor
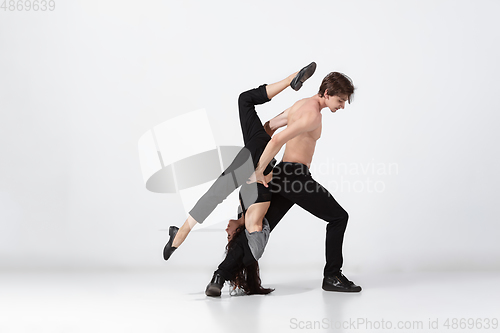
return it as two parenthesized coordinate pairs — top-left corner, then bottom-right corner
(0, 0), (500, 277)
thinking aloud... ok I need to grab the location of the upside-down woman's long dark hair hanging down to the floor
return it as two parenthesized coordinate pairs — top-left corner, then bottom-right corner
(226, 225), (274, 295)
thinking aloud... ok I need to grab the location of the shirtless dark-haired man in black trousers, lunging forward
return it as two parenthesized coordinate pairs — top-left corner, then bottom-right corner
(207, 72), (361, 296)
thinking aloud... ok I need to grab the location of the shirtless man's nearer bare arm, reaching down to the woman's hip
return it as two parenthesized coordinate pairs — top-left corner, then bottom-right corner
(251, 109), (321, 187)
